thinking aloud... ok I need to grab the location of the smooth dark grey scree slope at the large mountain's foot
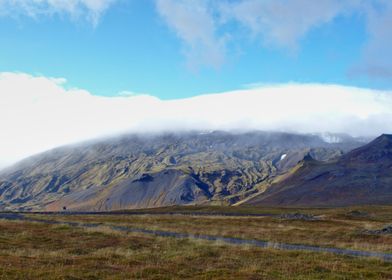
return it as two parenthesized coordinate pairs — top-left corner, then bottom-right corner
(47, 169), (211, 211)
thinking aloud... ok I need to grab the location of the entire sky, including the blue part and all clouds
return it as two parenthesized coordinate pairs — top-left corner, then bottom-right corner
(0, 0), (392, 168)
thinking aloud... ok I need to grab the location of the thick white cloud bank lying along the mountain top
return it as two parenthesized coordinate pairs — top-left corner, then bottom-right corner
(0, 73), (392, 167)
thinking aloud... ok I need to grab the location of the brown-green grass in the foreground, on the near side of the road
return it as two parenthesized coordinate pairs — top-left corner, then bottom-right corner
(0, 221), (392, 279)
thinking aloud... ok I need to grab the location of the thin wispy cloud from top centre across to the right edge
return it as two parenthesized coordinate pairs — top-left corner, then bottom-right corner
(156, 0), (392, 79)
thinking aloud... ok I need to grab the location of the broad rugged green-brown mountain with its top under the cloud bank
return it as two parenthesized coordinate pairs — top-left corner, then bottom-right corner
(0, 131), (363, 211)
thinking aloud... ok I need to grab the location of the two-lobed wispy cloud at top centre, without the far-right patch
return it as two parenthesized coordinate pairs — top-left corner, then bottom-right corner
(156, 0), (356, 66)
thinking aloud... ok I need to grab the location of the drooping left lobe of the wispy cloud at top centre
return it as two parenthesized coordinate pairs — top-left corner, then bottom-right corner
(157, 0), (226, 69)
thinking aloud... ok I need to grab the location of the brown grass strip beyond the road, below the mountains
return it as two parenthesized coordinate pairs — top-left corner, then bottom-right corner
(28, 207), (392, 252)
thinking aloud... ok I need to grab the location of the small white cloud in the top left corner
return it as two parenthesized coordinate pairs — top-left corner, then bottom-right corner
(0, 0), (116, 25)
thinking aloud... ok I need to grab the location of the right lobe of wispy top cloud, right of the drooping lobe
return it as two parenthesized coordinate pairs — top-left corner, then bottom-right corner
(220, 0), (353, 49)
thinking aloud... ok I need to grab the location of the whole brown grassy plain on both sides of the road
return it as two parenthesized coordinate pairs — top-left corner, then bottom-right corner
(0, 207), (392, 279)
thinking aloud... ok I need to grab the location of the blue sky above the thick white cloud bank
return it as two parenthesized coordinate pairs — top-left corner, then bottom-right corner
(0, 0), (392, 99)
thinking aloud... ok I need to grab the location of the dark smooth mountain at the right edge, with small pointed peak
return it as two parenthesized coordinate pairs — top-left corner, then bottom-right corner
(244, 134), (392, 206)
